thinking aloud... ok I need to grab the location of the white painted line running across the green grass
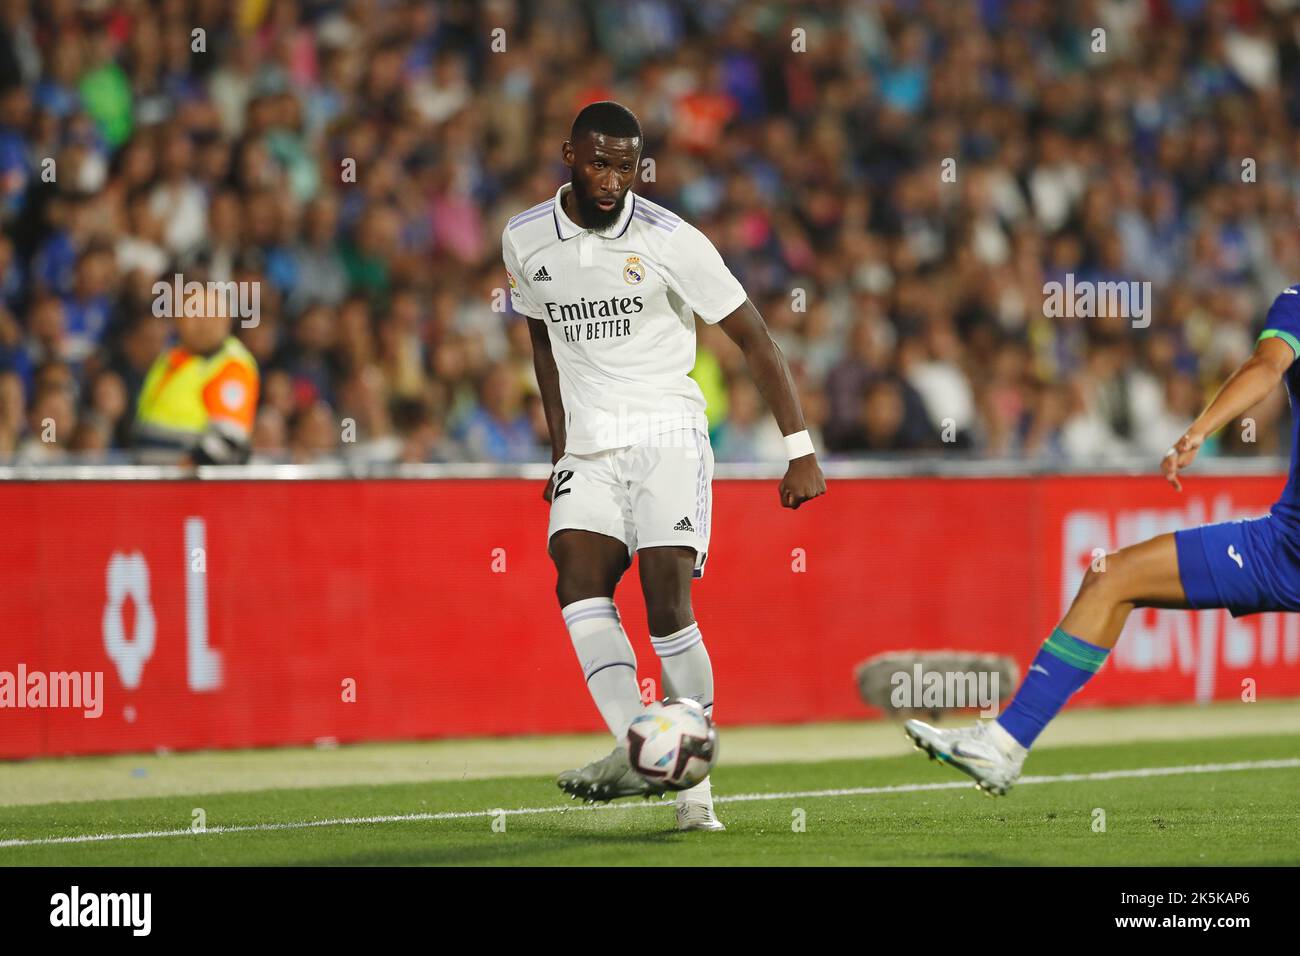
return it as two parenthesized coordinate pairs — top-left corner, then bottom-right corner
(0, 757), (1300, 849)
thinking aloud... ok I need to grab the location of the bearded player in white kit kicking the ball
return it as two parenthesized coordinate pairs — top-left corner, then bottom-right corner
(502, 101), (826, 830)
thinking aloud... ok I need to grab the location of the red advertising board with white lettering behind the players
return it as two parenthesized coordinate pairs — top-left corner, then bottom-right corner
(0, 477), (1300, 757)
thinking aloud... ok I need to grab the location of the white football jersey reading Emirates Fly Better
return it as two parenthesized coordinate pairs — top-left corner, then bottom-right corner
(501, 183), (745, 454)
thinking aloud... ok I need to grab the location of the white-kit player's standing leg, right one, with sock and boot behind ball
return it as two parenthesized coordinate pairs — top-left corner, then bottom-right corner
(637, 546), (725, 830)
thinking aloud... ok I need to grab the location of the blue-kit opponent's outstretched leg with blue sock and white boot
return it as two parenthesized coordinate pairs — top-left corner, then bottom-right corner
(906, 532), (1190, 795)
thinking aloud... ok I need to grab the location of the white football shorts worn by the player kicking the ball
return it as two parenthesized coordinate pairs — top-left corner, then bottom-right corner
(546, 429), (714, 578)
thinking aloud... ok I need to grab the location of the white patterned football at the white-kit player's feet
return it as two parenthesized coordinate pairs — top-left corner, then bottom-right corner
(628, 697), (718, 790)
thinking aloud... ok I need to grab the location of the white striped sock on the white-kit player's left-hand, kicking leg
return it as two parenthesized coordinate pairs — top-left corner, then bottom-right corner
(560, 597), (642, 743)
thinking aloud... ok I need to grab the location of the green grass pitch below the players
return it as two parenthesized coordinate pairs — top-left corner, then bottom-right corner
(0, 734), (1300, 866)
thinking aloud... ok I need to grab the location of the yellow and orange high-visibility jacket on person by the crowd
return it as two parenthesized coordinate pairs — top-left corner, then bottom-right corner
(135, 336), (259, 447)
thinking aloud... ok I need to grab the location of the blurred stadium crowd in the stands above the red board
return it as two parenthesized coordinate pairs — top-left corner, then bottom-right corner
(0, 0), (1300, 463)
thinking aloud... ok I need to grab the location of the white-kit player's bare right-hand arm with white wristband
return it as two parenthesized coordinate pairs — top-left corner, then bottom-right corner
(719, 298), (826, 509)
